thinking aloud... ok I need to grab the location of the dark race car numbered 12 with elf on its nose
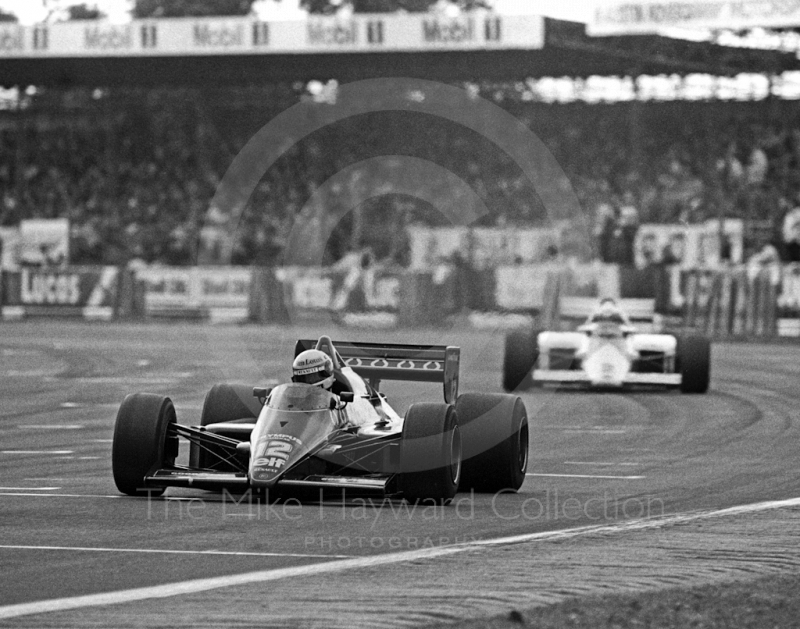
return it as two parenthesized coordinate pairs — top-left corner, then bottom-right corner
(112, 336), (528, 504)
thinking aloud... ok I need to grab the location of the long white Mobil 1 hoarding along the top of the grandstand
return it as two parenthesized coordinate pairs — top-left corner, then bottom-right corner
(0, 11), (544, 59)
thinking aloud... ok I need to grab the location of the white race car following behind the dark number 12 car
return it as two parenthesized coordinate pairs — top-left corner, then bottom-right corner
(503, 300), (711, 393)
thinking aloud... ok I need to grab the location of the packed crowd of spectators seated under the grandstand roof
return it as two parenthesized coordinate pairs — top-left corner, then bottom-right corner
(0, 85), (800, 265)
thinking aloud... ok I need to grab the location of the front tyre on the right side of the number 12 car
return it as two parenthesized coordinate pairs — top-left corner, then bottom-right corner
(398, 404), (461, 504)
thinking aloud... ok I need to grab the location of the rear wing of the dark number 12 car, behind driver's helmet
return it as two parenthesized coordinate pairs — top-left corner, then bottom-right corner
(295, 336), (461, 404)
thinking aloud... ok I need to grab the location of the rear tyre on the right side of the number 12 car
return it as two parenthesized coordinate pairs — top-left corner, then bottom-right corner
(456, 393), (530, 493)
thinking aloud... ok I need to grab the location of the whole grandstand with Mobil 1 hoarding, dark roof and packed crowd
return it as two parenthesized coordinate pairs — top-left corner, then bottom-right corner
(0, 12), (800, 266)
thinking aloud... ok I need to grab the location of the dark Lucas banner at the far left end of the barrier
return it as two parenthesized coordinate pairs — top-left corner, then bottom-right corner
(2, 267), (119, 320)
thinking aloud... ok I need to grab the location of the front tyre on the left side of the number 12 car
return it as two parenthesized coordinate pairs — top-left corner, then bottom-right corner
(111, 393), (178, 496)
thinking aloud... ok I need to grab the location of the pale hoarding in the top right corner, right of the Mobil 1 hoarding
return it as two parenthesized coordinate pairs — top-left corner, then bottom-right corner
(587, 0), (800, 35)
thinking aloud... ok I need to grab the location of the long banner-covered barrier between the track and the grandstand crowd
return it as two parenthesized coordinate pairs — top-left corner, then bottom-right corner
(0, 263), (800, 338)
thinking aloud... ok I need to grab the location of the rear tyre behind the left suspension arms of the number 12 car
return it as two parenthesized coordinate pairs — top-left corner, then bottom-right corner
(189, 384), (261, 470)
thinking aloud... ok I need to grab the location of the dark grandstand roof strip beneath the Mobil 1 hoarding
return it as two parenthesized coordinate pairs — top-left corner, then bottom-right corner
(0, 19), (800, 87)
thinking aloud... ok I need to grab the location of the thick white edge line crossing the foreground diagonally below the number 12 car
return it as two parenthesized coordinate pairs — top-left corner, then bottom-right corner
(0, 498), (800, 620)
